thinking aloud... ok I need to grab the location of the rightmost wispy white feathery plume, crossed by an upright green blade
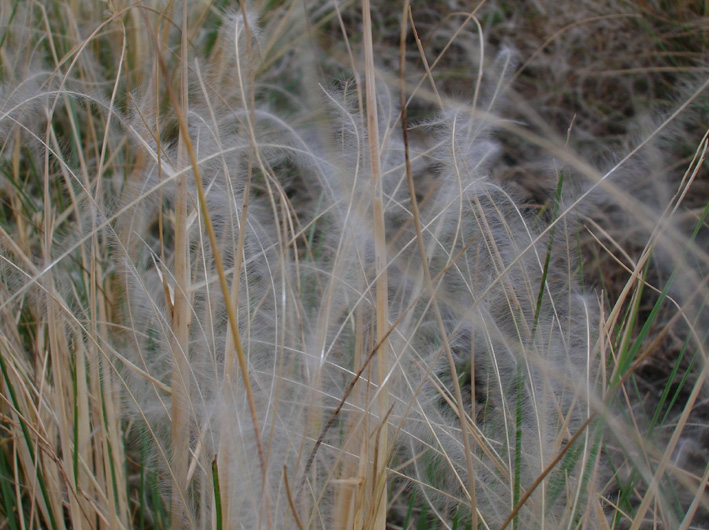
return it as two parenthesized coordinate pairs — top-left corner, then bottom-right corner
(392, 106), (600, 528)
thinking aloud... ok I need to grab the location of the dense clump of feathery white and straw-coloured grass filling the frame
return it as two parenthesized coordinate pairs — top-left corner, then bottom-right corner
(0, 2), (706, 528)
